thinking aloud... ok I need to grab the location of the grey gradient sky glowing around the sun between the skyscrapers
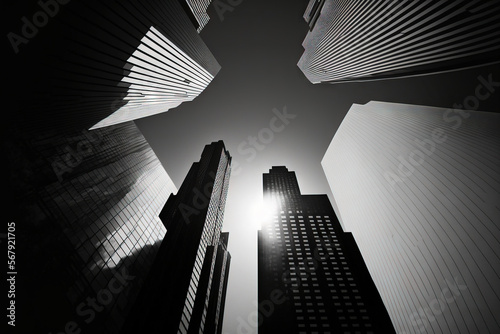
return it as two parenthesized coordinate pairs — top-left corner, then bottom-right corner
(136, 0), (500, 334)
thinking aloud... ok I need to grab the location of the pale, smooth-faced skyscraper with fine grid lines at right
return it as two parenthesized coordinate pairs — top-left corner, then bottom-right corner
(322, 102), (500, 333)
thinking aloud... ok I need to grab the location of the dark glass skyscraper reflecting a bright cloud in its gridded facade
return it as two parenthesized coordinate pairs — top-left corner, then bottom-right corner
(4, 122), (176, 334)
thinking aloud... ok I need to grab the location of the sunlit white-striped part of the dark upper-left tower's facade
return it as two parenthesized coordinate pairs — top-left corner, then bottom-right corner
(92, 27), (214, 129)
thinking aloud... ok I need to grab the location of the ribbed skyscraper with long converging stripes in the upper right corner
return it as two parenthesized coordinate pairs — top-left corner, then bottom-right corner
(298, 0), (500, 84)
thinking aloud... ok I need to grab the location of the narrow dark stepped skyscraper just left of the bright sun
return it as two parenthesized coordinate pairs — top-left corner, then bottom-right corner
(123, 141), (231, 334)
